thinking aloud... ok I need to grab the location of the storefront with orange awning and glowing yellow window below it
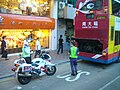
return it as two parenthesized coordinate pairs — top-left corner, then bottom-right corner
(0, 14), (55, 53)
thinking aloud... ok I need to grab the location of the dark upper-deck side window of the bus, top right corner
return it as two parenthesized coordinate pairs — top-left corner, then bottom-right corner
(112, 0), (120, 16)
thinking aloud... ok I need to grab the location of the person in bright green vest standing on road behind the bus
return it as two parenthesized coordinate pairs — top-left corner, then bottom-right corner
(69, 42), (79, 76)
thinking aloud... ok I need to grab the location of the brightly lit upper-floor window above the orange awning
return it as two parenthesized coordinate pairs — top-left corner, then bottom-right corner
(0, 0), (50, 17)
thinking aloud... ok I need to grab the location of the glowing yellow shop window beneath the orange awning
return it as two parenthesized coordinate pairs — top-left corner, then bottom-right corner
(0, 29), (50, 49)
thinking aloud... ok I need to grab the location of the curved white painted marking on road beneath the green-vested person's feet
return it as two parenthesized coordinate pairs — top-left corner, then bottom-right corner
(57, 70), (90, 82)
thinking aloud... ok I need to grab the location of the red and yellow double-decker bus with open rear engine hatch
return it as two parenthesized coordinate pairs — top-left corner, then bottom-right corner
(74, 0), (120, 64)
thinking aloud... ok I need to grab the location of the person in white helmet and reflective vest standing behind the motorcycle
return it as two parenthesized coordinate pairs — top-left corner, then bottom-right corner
(22, 37), (31, 64)
